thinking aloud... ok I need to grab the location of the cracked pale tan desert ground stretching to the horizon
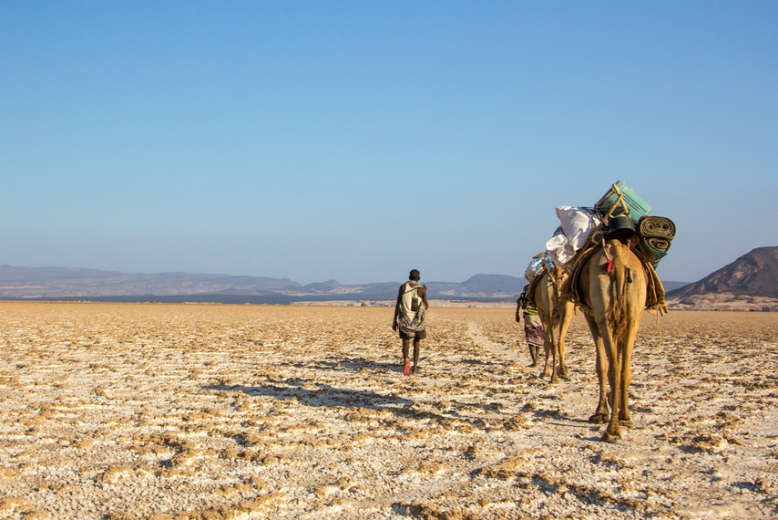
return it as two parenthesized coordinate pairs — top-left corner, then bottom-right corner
(0, 302), (778, 520)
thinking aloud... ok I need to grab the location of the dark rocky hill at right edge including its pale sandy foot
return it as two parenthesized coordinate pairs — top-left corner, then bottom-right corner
(666, 247), (778, 310)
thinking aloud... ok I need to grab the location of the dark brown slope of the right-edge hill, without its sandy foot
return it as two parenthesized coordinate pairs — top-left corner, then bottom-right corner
(667, 247), (778, 302)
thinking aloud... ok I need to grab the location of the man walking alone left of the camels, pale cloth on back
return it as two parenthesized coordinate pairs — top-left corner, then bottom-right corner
(392, 269), (429, 376)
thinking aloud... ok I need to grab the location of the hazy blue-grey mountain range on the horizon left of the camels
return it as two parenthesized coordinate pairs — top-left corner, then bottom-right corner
(0, 265), (526, 303)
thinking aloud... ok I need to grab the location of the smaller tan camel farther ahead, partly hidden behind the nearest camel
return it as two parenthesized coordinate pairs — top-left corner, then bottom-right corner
(531, 267), (575, 383)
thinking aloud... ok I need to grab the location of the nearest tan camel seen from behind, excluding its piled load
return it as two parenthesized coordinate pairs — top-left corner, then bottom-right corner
(576, 239), (649, 441)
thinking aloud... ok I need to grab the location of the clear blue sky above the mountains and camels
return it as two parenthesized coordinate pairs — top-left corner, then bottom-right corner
(0, 0), (778, 283)
